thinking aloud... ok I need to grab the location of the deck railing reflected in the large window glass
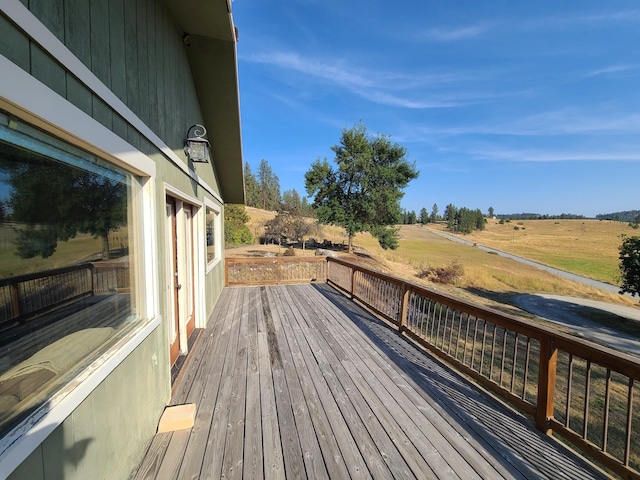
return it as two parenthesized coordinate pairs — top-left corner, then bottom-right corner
(0, 262), (129, 329)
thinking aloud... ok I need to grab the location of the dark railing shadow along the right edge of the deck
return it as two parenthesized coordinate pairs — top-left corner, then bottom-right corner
(314, 284), (607, 479)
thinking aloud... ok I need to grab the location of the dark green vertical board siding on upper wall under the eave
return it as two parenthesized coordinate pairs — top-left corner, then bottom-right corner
(0, 0), (202, 153)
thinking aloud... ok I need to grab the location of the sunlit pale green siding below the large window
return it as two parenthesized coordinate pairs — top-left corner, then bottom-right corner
(9, 329), (170, 480)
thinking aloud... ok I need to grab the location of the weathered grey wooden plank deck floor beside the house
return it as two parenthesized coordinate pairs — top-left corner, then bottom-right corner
(135, 284), (605, 480)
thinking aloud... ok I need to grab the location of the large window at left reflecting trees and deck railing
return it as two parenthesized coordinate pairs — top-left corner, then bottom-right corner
(0, 112), (144, 434)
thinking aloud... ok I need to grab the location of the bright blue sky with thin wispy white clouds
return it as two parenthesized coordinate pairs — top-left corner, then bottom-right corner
(233, 0), (640, 216)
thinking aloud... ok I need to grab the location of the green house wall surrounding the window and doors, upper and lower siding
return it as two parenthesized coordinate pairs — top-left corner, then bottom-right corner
(0, 0), (230, 480)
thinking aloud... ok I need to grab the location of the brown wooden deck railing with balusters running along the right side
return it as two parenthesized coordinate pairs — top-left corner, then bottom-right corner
(327, 258), (640, 479)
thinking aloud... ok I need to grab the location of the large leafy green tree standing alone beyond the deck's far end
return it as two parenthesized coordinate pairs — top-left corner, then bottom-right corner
(305, 122), (418, 252)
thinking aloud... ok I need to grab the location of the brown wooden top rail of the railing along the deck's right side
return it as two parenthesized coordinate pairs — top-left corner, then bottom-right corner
(327, 257), (640, 380)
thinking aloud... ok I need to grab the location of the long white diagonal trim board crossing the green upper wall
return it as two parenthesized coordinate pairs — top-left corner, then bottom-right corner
(0, 0), (222, 203)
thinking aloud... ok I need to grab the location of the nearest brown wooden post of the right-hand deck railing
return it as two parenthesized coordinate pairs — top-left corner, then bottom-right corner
(536, 336), (558, 435)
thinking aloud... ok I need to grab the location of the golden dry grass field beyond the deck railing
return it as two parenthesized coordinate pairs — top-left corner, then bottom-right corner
(227, 208), (637, 309)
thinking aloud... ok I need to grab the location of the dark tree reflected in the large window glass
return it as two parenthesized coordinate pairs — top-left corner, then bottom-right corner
(0, 145), (127, 260)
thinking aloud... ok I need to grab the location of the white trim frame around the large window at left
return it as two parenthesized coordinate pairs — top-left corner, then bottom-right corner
(0, 53), (161, 478)
